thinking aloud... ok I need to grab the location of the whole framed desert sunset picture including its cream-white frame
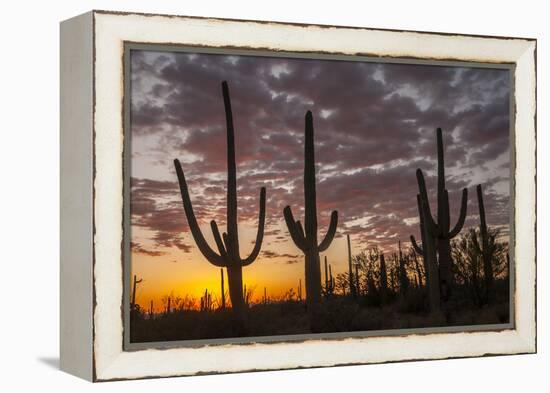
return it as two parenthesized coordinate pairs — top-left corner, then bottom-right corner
(60, 11), (536, 381)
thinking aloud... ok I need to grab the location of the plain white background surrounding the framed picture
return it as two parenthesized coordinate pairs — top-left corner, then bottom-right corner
(0, 0), (550, 393)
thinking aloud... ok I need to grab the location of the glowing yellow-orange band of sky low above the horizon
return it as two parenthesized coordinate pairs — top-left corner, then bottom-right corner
(131, 217), (360, 312)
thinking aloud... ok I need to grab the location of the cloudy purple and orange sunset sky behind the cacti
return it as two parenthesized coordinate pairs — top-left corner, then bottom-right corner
(130, 50), (511, 310)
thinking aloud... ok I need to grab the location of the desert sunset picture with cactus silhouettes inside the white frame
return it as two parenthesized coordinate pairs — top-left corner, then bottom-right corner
(125, 47), (513, 343)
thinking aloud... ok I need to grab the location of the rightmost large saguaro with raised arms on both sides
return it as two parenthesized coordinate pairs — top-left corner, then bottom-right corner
(416, 128), (468, 301)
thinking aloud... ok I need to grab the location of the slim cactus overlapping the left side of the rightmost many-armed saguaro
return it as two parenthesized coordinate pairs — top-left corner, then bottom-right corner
(411, 194), (441, 312)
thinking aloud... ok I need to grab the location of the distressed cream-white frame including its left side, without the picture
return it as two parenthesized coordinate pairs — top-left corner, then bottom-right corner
(60, 11), (536, 381)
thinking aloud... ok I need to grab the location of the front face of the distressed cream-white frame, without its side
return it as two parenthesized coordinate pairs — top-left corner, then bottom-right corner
(66, 12), (536, 380)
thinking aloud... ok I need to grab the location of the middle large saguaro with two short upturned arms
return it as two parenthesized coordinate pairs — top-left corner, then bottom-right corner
(283, 111), (338, 332)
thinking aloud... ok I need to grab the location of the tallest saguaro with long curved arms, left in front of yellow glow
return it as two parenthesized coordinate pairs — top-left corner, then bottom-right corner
(174, 81), (265, 334)
